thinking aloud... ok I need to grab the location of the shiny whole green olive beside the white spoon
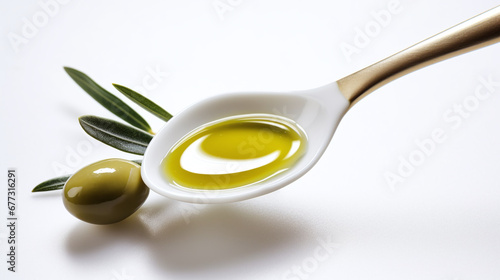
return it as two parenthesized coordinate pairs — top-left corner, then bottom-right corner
(63, 159), (149, 225)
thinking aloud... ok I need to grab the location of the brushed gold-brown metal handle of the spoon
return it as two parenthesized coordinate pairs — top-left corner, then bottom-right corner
(337, 6), (500, 103)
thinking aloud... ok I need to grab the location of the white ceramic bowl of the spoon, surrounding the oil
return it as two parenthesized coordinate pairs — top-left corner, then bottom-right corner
(142, 83), (349, 203)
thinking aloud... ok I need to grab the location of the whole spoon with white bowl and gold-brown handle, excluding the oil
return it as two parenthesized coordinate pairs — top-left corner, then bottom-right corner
(142, 6), (500, 203)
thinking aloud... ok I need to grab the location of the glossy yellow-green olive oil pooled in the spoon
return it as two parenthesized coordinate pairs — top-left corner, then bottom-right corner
(162, 114), (307, 190)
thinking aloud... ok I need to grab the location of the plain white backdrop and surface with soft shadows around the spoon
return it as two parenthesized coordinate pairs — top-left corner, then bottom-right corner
(0, 0), (500, 280)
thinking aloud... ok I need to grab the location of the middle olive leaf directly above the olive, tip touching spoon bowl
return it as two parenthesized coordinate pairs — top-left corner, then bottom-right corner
(78, 115), (153, 155)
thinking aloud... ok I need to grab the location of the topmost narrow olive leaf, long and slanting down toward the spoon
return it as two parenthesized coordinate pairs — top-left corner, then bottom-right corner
(64, 67), (152, 132)
